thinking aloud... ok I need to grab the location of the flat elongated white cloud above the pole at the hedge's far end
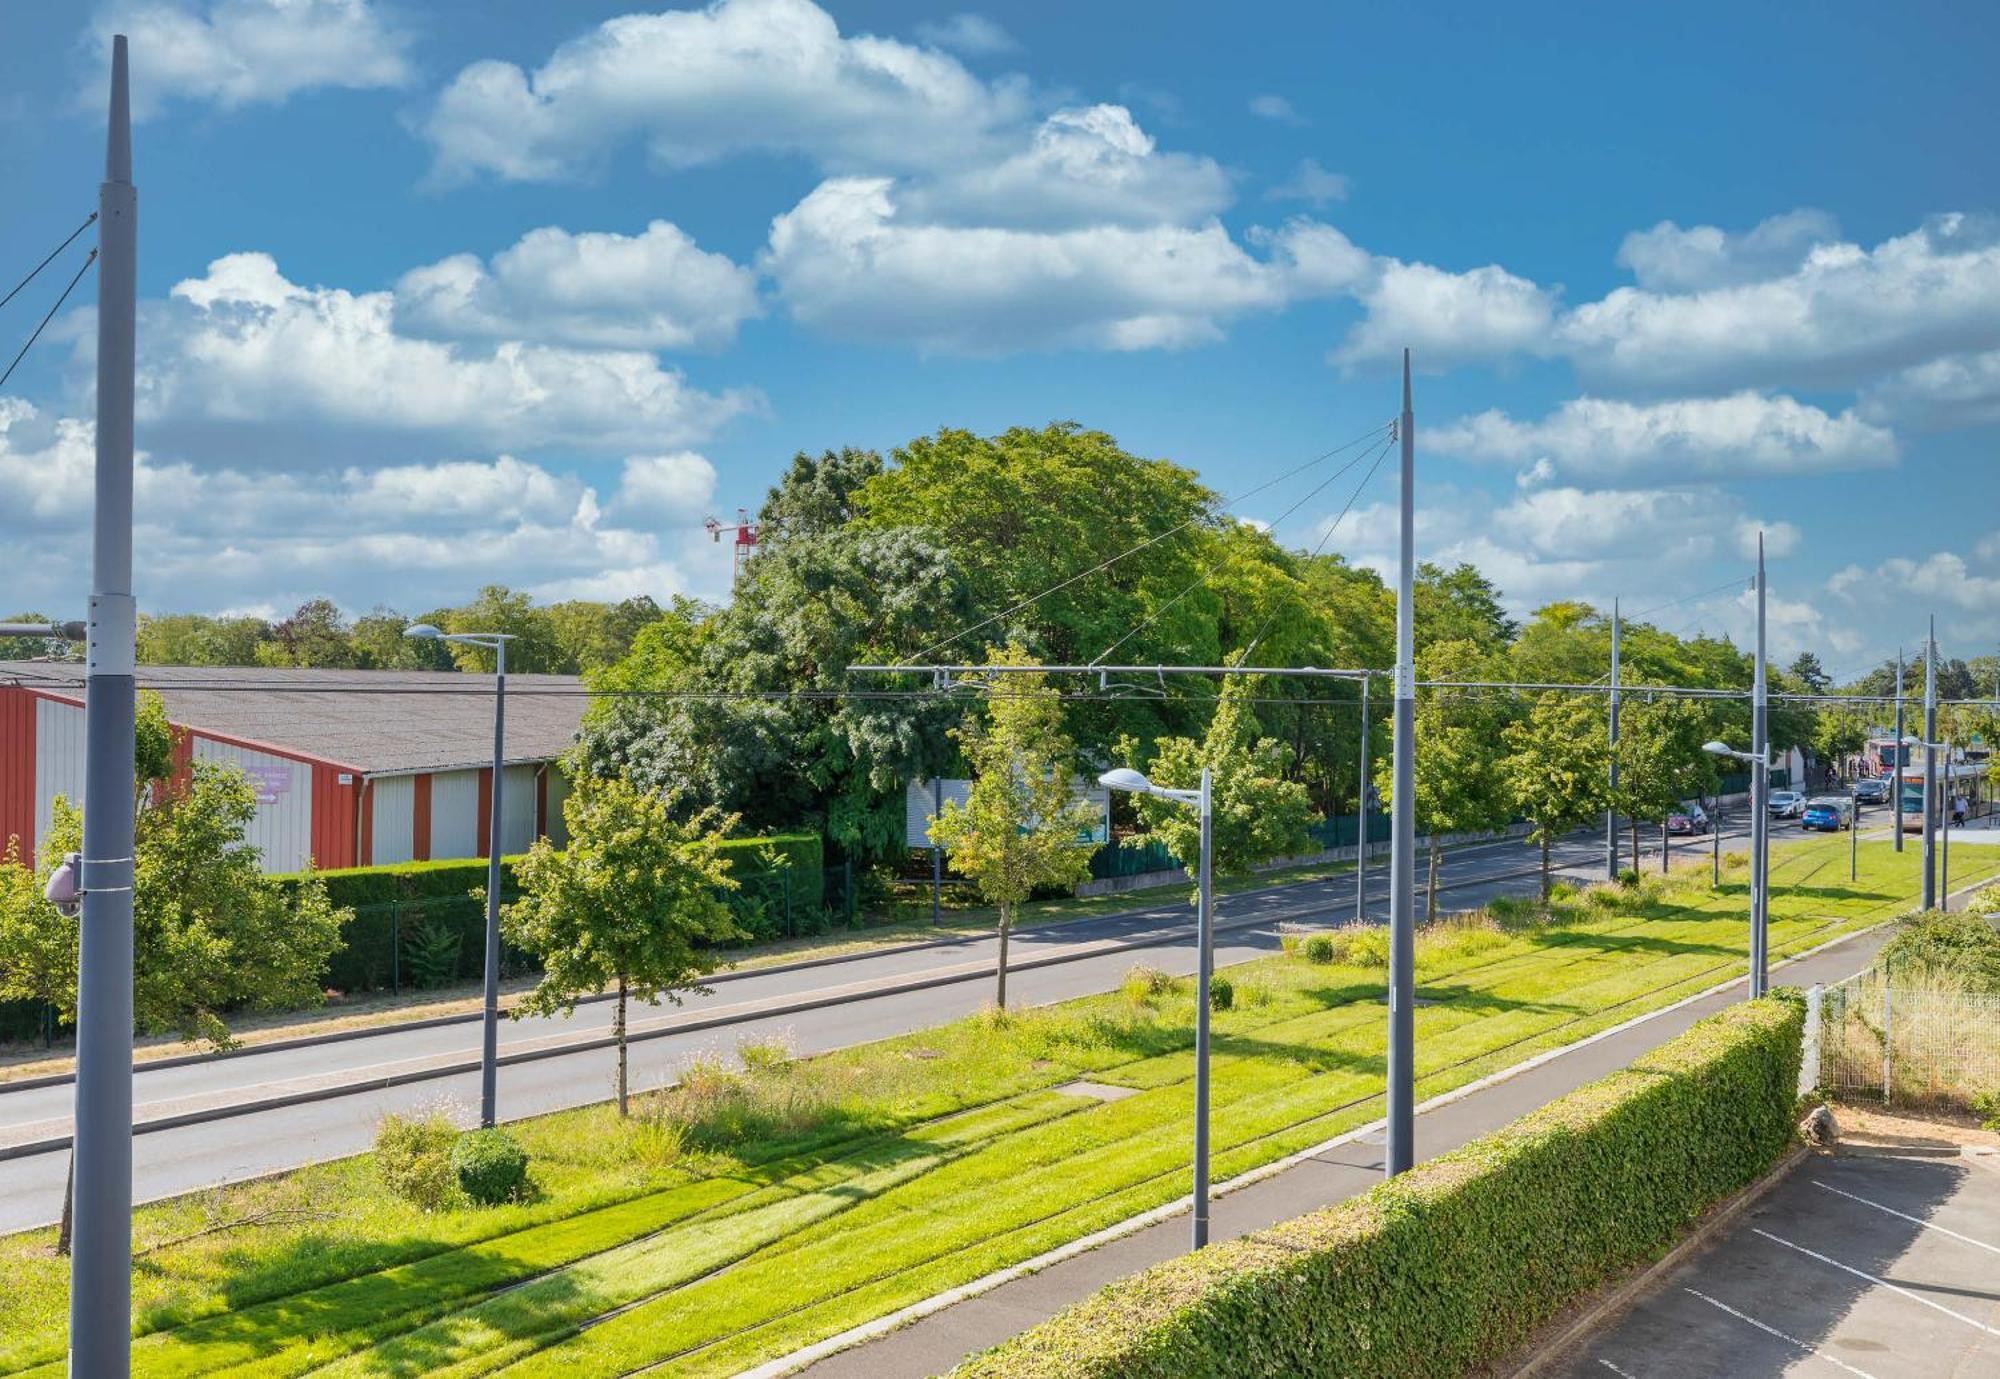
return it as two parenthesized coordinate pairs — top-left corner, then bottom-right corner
(1424, 392), (1896, 484)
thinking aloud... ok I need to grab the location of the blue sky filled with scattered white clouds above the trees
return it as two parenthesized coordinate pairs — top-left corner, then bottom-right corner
(0, 0), (2000, 678)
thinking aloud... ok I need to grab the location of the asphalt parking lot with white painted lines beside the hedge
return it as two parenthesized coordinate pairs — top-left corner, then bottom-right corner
(1542, 1151), (2000, 1379)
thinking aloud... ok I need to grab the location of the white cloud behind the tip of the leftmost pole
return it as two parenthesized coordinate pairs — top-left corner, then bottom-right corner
(80, 0), (414, 118)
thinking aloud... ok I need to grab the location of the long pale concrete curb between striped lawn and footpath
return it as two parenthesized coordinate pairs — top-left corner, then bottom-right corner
(734, 919), (1894, 1379)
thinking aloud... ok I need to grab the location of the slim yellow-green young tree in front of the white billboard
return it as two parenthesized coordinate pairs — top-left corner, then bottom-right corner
(930, 646), (1094, 1009)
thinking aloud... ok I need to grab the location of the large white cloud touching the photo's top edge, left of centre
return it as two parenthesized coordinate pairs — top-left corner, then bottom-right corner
(422, 0), (1030, 182)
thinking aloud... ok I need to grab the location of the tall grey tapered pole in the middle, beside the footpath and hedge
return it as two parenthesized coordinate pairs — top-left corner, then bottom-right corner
(1382, 350), (1416, 1177)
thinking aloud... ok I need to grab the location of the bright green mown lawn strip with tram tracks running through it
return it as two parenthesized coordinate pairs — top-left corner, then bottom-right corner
(0, 837), (2000, 1375)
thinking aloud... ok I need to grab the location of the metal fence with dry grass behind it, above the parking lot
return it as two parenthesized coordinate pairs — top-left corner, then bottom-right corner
(1818, 975), (2000, 1107)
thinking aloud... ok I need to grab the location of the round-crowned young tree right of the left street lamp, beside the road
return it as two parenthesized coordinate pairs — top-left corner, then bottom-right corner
(500, 775), (742, 1115)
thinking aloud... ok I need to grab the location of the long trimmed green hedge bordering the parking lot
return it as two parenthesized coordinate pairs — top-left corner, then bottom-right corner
(952, 991), (1804, 1379)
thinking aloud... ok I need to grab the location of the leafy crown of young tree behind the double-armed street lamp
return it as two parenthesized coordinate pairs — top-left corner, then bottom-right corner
(1120, 676), (1312, 903)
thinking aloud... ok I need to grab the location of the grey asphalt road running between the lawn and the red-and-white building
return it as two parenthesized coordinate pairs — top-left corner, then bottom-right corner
(0, 807), (1794, 1231)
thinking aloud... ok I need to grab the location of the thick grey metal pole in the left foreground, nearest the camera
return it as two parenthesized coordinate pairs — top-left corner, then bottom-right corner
(70, 34), (138, 1379)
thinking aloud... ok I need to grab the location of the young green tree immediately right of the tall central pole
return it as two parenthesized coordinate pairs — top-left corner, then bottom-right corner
(1376, 642), (1512, 923)
